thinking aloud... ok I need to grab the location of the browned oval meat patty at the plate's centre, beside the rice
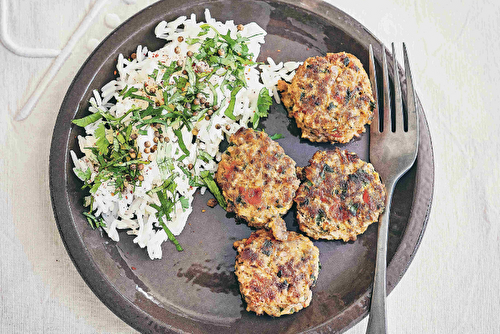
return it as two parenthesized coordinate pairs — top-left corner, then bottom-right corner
(216, 128), (300, 239)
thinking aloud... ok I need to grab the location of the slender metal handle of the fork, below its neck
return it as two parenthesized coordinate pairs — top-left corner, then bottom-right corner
(366, 181), (394, 334)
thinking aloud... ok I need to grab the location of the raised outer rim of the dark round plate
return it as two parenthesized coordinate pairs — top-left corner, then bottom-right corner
(49, 0), (435, 332)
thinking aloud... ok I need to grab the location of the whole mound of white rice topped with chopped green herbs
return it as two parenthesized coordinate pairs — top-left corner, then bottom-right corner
(71, 11), (296, 259)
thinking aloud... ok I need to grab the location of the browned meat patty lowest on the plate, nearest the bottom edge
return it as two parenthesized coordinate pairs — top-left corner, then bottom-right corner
(234, 230), (320, 317)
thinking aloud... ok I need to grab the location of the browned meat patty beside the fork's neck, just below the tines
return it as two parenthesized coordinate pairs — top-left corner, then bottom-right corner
(295, 148), (386, 241)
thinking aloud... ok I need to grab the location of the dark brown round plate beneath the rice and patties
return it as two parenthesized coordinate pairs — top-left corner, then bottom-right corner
(50, 0), (434, 333)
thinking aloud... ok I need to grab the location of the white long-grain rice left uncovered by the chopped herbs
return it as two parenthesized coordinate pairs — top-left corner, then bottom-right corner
(71, 9), (299, 259)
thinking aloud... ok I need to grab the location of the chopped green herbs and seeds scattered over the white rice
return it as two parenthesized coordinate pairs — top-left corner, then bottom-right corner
(72, 18), (270, 251)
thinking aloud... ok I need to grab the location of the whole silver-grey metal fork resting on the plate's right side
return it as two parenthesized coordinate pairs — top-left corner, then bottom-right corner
(367, 43), (419, 334)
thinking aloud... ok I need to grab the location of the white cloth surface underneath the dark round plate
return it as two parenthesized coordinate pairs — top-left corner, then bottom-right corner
(0, 0), (500, 334)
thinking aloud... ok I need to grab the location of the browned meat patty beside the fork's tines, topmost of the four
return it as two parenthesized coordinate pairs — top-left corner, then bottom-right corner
(278, 52), (375, 143)
